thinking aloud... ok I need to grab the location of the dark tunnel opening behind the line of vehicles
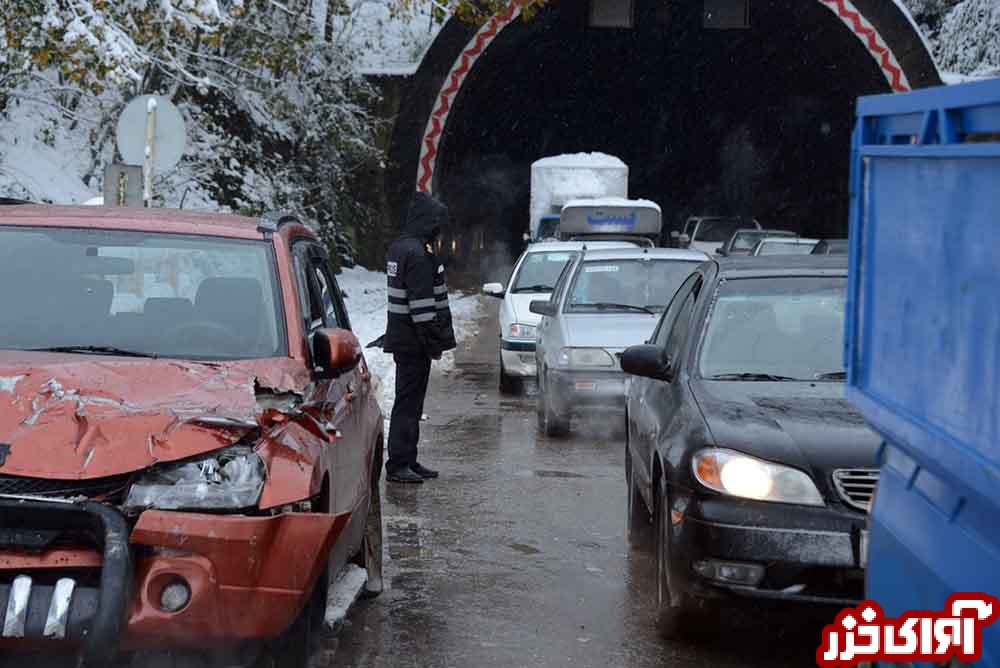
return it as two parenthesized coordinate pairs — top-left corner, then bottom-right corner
(388, 0), (938, 278)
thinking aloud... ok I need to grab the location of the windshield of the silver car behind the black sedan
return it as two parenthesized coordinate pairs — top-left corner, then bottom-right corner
(566, 259), (699, 312)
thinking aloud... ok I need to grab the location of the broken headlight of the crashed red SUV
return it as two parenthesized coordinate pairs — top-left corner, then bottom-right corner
(125, 445), (265, 510)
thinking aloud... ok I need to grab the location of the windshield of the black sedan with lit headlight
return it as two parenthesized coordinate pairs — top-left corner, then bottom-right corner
(699, 277), (846, 381)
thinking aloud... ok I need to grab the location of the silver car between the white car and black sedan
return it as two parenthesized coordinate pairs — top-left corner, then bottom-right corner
(530, 248), (708, 436)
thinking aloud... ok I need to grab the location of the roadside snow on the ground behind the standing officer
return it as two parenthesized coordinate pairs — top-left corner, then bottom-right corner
(337, 267), (483, 417)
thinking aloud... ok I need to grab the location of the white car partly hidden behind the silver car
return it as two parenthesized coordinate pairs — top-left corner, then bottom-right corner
(483, 241), (636, 394)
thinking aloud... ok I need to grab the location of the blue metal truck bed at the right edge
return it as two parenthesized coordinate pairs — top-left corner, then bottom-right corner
(845, 79), (1000, 668)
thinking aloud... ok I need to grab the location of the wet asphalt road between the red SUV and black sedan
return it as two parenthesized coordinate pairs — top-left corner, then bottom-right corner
(334, 308), (835, 668)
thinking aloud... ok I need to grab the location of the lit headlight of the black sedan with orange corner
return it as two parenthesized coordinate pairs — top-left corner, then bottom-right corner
(691, 448), (825, 506)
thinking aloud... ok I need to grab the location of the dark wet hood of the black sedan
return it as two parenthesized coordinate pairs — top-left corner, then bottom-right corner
(691, 381), (881, 495)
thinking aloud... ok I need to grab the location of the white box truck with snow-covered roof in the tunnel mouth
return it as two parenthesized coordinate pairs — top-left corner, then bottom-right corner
(530, 153), (629, 241)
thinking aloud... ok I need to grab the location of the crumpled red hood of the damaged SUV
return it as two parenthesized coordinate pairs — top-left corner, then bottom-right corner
(0, 351), (310, 480)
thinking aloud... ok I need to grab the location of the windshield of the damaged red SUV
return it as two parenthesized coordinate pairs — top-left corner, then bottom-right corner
(0, 227), (286, 360)
